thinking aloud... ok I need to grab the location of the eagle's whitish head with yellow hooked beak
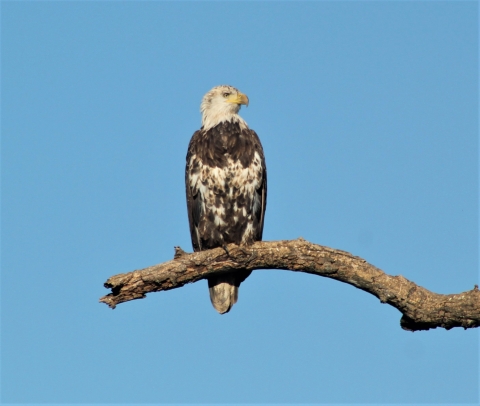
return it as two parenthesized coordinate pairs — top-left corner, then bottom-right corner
(200, 85), (248, 130)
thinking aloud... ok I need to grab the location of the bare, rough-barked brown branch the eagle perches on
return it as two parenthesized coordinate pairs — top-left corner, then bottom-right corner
(100, 238), (480, 331)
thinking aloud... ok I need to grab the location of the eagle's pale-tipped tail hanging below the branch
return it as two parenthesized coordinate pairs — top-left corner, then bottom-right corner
(208, 273), (240, 314)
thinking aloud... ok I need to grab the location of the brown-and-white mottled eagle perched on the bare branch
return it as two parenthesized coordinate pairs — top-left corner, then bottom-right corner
(185, 85), (267, 314)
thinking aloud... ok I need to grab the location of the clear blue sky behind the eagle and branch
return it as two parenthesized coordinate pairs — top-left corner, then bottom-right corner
(1, 1), (479, 404)
